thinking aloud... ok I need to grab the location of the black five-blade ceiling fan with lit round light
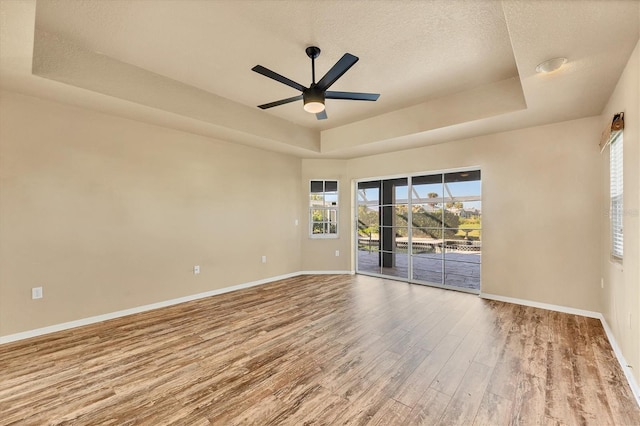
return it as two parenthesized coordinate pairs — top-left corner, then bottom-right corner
(251, 46), (380, 120)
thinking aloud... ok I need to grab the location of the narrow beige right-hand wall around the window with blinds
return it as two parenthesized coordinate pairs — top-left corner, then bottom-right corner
(600, 43), (640, 383)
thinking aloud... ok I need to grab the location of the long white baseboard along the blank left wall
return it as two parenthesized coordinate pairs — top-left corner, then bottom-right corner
(0, 272), (303, 344)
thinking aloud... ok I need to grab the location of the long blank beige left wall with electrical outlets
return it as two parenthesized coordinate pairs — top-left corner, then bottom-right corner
(0, 92), (301, 336)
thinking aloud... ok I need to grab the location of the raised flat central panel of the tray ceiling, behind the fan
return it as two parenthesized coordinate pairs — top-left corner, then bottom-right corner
(31, 0), (517, 129)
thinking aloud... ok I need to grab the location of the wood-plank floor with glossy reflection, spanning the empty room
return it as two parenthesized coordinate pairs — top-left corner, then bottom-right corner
(0, 275), (640, 426)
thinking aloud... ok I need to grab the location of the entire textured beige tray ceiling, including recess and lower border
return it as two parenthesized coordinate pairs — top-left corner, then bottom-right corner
(0, 0), (640, 158)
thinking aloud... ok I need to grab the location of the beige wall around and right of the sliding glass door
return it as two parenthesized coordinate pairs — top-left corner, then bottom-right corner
(302, 117), (601, 311)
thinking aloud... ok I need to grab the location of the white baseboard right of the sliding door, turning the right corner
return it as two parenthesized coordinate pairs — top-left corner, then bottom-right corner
(480, 293), (640, 406)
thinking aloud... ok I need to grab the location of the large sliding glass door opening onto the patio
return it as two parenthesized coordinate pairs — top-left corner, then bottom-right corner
(356, 170), (482, 292)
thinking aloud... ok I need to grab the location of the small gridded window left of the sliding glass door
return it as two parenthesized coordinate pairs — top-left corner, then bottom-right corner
(309, 180), (338, 238)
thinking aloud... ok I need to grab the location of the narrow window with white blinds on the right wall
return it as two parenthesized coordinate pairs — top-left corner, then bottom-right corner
(609, 132), (624, 260)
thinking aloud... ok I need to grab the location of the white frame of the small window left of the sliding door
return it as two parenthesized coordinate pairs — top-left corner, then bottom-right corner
(307, 179), (340, 239)
